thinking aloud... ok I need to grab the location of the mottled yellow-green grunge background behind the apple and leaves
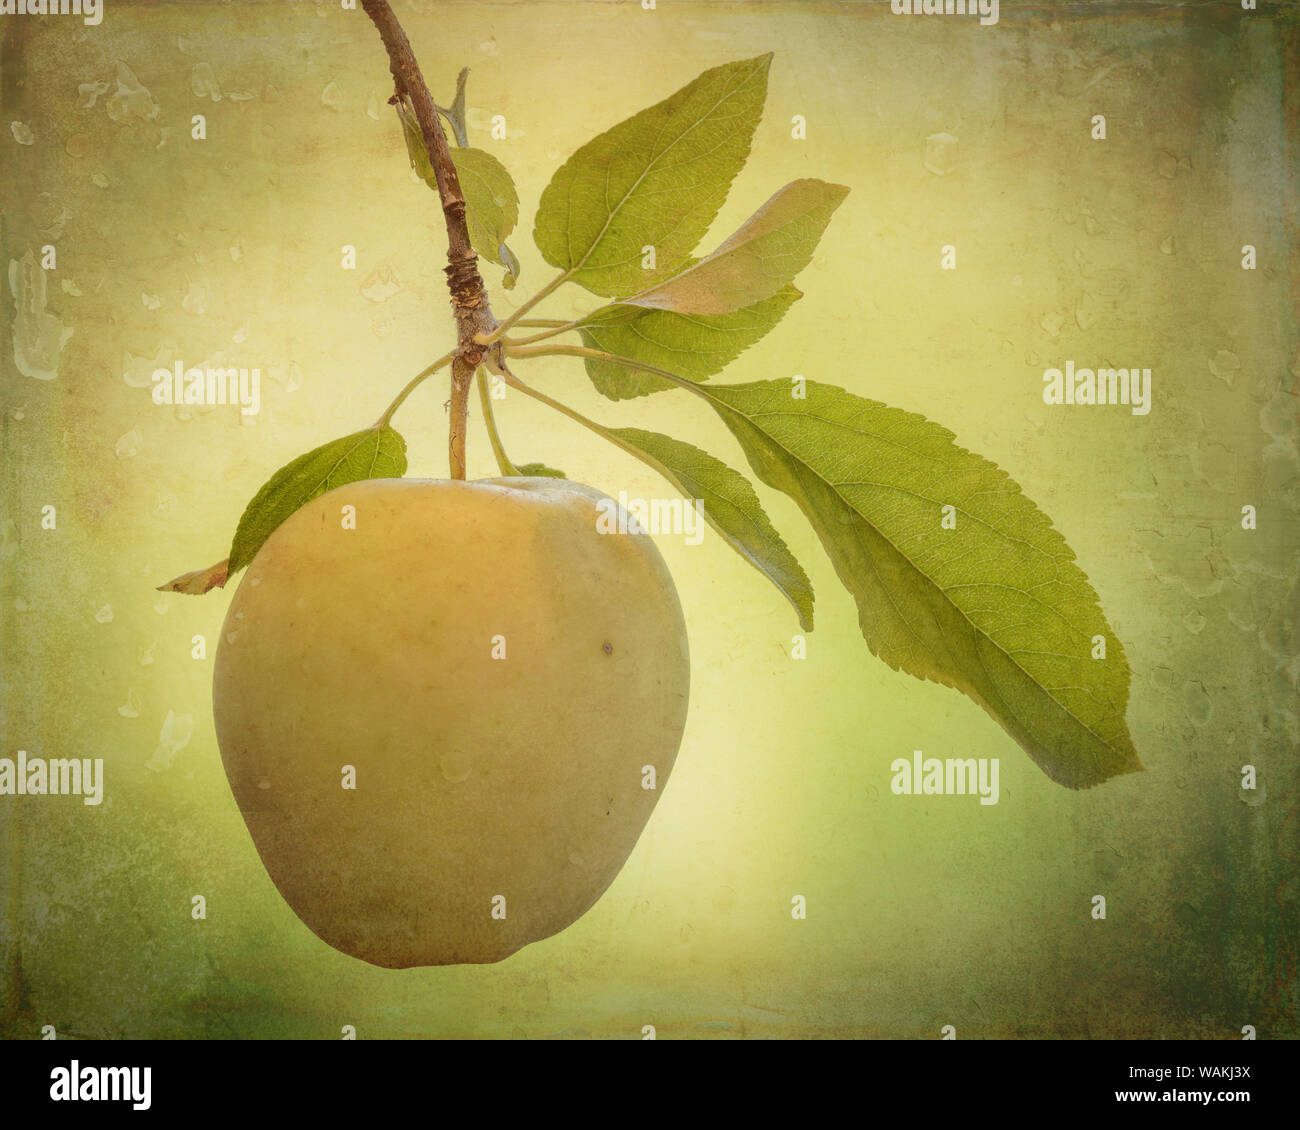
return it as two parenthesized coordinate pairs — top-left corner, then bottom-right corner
(0, 0), (1300, 1039)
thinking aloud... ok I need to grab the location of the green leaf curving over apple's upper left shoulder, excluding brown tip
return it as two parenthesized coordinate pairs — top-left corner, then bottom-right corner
(229, 425), (406, 573)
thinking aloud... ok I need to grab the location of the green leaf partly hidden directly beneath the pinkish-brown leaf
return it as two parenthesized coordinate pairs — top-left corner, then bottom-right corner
(579, 286), (802, 401)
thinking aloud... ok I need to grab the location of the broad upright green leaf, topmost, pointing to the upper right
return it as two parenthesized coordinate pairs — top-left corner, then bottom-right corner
(533, 55), (772, 298)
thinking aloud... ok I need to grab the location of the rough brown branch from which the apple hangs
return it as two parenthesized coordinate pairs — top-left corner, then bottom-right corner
(361, 0), (501, 479)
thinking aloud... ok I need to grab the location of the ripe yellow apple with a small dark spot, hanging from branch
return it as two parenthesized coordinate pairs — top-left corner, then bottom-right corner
(213, 477), (689, 969)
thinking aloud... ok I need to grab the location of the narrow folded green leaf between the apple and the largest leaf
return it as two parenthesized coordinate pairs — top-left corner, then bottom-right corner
(601, 428), (813, 632)
